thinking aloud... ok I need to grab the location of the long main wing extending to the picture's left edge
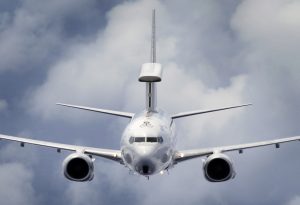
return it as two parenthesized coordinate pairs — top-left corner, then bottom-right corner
(0, 134), (122, 163)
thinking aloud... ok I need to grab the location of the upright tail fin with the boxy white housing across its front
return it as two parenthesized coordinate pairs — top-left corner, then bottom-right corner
(139, 9), (162, 112)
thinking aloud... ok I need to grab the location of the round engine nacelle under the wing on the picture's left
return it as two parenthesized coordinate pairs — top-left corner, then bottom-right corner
(63, 153), (94, 182)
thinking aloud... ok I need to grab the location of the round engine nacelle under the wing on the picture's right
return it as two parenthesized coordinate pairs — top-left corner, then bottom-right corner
(203, 153), (235, 182)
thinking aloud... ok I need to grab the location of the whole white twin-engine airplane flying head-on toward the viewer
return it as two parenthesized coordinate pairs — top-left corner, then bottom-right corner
(0, 10), (300, 182)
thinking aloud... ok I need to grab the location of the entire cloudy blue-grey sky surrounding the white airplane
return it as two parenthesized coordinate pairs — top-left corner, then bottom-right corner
(0, 0), (300, 205)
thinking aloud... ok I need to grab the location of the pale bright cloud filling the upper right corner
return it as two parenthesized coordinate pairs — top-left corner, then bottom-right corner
(231, 0), (300, 73)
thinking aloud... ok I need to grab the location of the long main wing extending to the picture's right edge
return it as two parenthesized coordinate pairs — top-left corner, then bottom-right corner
(174, 136), (300, 163)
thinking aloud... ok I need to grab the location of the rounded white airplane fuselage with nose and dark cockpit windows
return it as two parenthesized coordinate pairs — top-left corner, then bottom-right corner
(121, 110), (176, 176)
